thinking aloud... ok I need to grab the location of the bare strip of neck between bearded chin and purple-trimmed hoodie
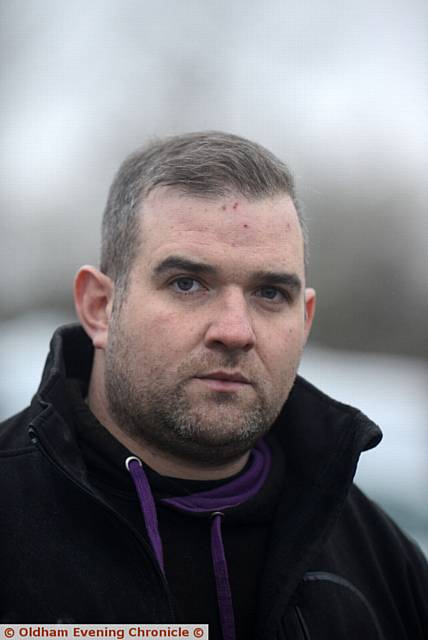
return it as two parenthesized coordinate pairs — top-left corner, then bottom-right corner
(86, 357), (250, 480)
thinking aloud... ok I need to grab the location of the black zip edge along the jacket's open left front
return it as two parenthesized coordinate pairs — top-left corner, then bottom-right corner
(28, 423), (177, 622)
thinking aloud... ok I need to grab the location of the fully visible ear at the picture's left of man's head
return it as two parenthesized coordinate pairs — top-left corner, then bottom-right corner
(74, 265), (114, 349)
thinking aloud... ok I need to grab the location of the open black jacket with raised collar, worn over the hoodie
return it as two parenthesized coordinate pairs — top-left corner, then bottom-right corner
(0, 326), (428, 640)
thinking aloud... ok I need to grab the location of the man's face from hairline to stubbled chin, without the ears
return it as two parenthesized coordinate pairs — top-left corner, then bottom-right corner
(105, 189), (313, 465)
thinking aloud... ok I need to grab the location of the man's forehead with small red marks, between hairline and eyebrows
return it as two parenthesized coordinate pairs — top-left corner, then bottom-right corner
(140, 189), (304, 274)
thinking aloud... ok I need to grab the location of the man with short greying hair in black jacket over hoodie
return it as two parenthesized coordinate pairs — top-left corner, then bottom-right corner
(0, 132), (428, 640)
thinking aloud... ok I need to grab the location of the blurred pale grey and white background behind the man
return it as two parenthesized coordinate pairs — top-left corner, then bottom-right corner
(0, 0), (428, 553)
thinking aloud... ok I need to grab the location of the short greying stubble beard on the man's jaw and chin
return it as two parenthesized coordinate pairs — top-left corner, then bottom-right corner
(105, 320), (295, 466)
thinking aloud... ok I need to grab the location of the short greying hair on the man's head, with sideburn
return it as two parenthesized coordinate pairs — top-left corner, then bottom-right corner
(101, 131), (307, 294)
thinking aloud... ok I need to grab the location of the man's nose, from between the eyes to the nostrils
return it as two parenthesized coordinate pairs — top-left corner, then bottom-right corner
(205, 291), (256, 351)
